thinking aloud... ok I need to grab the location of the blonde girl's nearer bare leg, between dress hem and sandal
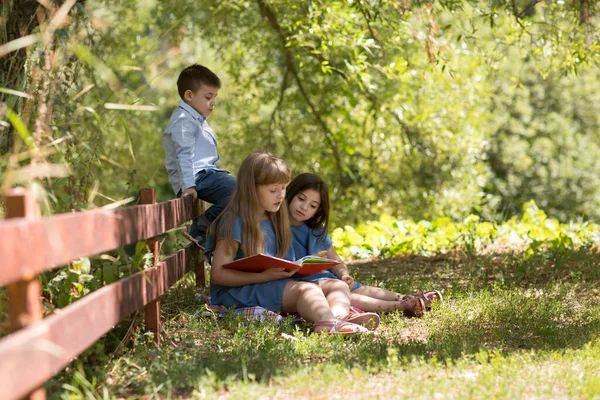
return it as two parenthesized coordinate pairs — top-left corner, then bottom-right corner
(282, 281), (335, 322)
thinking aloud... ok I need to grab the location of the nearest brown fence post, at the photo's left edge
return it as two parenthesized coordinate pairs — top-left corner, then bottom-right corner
(6, 188), (46, 400)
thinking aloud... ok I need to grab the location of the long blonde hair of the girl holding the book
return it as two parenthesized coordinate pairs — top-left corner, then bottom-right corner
(210, 152), (292, 258)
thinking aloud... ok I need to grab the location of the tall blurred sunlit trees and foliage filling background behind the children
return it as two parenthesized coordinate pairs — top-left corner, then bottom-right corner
(0, 0), (600, 225)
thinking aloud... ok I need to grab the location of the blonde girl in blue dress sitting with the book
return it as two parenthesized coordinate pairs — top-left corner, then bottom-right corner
(207, 152), (368, 334)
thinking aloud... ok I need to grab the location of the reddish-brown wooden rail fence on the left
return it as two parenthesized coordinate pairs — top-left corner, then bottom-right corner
(0, 189), (205, 400)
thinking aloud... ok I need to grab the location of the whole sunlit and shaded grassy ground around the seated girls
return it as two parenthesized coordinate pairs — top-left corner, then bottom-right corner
(47, 250), (600, 399)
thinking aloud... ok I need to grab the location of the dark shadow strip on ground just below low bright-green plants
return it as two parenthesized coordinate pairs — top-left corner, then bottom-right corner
(351, 248), (600, 292)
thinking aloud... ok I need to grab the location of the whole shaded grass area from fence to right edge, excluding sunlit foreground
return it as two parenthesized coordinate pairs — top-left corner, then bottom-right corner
(49, 247), (600, 397)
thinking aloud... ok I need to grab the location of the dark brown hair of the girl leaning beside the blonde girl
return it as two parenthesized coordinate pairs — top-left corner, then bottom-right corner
(285, 172), (329, 241)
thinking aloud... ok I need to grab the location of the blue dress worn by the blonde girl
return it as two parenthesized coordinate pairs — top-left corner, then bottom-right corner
(206, 215), (295, 313)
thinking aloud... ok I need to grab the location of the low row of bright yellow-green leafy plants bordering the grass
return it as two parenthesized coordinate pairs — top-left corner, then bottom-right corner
(331, 200), (600, 258)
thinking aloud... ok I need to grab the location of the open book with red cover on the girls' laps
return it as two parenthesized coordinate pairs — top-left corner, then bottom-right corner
(223, 253), (341, 276)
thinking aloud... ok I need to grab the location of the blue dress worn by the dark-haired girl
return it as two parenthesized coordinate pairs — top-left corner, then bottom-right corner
(292, 224), (363, 290)
